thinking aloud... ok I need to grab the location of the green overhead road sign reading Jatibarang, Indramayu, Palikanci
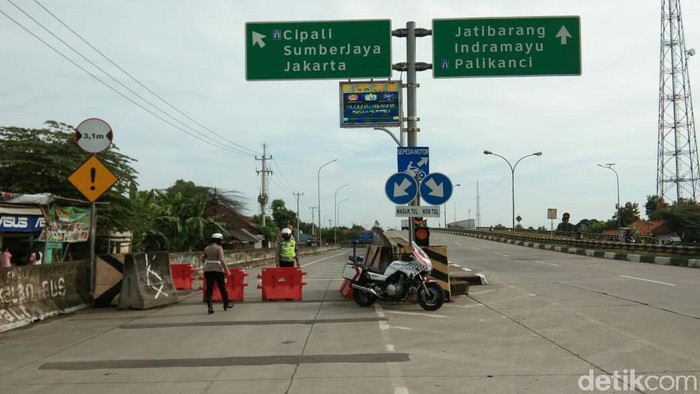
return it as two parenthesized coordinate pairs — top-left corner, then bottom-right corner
(433, 16), (581, 78)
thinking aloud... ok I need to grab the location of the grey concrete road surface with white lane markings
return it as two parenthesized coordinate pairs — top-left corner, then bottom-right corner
(0, 234), (700, 394)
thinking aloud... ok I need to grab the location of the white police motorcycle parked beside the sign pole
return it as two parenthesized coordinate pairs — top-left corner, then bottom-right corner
(343, 241), (445, 311)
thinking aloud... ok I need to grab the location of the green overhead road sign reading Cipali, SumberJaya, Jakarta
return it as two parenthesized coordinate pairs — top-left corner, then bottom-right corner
(245, 19), (391, 80)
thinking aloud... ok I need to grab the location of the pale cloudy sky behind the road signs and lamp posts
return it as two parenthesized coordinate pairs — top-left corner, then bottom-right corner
(0, 0), (700, 228)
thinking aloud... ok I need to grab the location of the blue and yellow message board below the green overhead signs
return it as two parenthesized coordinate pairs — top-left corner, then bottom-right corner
(340, 81), (401, 127)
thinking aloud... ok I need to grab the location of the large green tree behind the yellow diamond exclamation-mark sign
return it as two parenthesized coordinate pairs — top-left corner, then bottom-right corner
(0, 121), (138, 231)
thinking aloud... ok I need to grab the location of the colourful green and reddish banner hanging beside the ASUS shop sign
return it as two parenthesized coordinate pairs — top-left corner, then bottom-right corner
(40, 205), (90, 242)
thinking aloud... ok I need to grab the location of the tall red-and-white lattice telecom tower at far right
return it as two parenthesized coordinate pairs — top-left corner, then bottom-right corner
(656, 0), (700, 203)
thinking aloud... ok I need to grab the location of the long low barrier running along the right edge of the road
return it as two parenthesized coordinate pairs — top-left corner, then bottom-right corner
(438, 228), (700, 257)
